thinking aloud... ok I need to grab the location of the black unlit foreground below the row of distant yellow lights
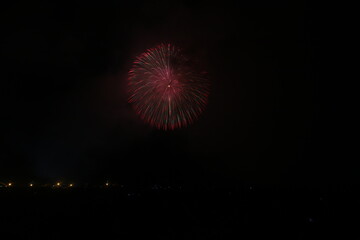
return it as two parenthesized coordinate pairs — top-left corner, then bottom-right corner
(0, 187), (358, 240)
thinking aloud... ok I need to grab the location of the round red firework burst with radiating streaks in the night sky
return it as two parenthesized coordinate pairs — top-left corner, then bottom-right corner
(128, 44), (209, 130)
